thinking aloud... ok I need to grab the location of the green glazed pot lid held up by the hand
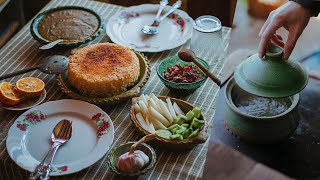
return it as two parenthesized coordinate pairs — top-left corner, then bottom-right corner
(234, 45), (308, 98)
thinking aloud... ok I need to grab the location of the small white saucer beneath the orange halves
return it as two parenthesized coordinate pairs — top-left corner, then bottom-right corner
(0, 89), (47, 111)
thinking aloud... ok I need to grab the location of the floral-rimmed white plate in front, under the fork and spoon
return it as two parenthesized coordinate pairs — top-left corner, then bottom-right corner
(6, 99), (114, 176)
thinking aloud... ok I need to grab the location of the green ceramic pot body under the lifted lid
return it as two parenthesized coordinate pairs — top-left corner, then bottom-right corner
(224, 78), (300, 144)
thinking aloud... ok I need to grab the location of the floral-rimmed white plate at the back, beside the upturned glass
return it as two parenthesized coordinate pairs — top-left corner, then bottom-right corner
(106, 4), (193, 52)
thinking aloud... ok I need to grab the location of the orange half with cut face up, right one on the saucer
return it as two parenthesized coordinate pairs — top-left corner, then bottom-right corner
(16, 77), (44, 98)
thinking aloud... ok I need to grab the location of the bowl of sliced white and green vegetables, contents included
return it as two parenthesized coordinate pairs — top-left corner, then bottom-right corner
(130, 94), (208, 150)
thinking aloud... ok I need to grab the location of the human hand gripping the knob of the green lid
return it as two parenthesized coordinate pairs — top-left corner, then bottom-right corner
(259, 1), (311, 60)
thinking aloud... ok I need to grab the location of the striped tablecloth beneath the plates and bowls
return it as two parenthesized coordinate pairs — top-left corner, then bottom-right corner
(0, 0), (231, 179)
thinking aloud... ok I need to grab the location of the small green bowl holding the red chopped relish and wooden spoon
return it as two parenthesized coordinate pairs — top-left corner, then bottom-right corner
(157, 56), (209, 95)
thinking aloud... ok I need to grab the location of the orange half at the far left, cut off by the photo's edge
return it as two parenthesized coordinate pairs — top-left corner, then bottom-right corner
(0, 82), (21, 106)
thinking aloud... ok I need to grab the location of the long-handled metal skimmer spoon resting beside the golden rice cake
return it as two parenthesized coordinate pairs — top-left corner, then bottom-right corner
(0, 55), (69, 81)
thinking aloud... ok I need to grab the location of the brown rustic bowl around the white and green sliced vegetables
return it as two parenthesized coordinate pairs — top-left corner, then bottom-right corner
(130, 96), (209, 150)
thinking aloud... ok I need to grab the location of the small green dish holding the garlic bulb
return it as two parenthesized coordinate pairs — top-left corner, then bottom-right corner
(108, 142), (157, 176)
